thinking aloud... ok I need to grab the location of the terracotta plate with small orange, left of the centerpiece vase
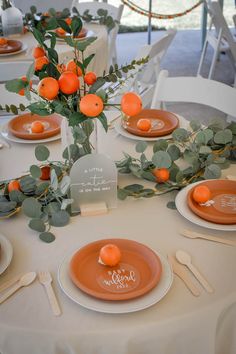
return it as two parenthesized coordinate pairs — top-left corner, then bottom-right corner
(8, 113), (61, 140)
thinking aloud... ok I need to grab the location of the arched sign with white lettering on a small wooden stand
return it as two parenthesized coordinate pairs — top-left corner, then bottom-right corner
(70, 154), (117, 215)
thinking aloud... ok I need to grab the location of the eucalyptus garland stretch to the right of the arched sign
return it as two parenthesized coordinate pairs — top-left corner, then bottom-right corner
(116, 119), (236, 200)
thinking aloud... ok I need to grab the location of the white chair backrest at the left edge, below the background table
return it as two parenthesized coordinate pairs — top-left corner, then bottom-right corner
(0, 61), (32, 82)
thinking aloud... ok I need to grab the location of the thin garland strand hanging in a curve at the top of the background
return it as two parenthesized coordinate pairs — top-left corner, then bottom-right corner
(121, 0), (203, 20)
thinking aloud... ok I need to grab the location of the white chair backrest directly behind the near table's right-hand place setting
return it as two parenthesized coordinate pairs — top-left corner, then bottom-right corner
(151, 70), (236, 118)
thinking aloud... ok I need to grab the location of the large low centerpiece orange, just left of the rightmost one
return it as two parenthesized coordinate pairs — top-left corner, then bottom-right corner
(79, 93), (104, 117)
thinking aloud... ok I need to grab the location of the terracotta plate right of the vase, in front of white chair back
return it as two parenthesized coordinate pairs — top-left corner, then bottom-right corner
(122, 109), (179, 137)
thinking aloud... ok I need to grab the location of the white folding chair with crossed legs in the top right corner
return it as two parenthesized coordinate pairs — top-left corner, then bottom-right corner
(197, 1), (236, 83)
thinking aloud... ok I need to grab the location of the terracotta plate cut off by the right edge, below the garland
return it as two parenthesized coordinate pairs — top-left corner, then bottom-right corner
(187, 180), (236, 225)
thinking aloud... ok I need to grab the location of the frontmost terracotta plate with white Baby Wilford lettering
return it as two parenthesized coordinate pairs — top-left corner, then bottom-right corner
(69, 239), (162, 301)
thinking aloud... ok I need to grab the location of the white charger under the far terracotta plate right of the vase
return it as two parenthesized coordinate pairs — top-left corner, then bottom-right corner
(114, 114), (189, 141)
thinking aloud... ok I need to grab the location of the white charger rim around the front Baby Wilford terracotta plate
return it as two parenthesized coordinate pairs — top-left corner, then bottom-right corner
(58, 251), (173, 314)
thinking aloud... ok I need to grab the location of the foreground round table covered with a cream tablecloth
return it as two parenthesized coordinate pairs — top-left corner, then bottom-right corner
(0, 86), (236, 354)
